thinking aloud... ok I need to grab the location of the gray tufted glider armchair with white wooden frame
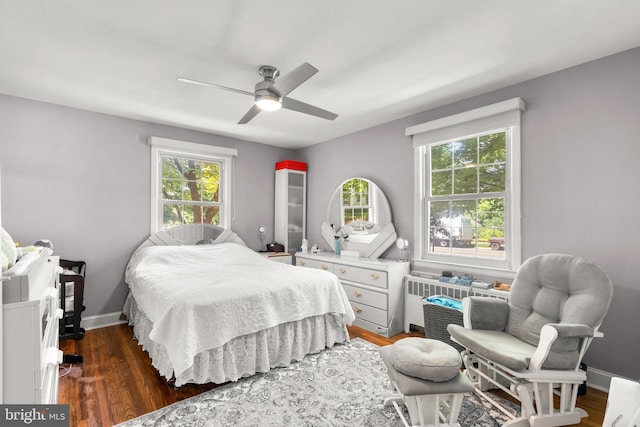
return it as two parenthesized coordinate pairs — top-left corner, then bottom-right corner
(447, 254), (613, 426)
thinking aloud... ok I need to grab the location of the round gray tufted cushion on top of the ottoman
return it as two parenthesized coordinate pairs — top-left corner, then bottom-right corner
(384, 338), (462, 382)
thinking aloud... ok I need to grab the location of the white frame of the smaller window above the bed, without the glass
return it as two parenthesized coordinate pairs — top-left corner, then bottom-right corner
(148, 136), (238, 234)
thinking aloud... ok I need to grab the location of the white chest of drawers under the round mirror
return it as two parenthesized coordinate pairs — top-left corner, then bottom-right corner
(296, 252), (409, 337)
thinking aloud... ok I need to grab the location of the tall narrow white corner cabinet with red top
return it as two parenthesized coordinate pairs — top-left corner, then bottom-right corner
(273, 160), (307, 254)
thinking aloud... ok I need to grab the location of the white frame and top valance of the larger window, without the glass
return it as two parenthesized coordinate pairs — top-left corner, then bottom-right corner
(405, 98), (525, 279)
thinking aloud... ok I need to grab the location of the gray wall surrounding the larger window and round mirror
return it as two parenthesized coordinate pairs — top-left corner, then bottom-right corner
(296, 48), (640, 379)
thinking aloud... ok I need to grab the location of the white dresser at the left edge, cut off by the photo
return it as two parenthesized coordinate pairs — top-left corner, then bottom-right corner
(2, 249), (62, 404)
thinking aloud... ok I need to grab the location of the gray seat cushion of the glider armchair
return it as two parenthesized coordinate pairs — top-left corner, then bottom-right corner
(447, 324), (536, 371)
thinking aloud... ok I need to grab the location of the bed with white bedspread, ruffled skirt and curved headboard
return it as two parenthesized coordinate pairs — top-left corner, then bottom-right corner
(123, 225), (355, 386)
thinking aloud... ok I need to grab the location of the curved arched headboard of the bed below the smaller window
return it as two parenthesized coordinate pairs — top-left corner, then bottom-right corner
(136, 224), (247, 251)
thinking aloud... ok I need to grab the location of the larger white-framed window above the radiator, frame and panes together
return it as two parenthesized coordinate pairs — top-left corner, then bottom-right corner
(407, 98), (524, 277)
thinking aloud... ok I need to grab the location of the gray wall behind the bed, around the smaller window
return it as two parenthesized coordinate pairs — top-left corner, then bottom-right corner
(0, 95), (291, 316)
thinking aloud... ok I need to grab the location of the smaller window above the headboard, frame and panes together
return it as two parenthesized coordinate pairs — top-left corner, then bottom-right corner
(149, 137), (237, 233)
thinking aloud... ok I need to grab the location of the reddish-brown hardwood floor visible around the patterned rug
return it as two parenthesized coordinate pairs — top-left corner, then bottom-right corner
(58, 325), (607, 426)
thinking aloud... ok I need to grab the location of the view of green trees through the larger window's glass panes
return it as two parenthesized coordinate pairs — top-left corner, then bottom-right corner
(427, 130), (508, 259)
